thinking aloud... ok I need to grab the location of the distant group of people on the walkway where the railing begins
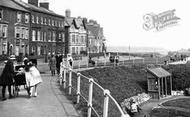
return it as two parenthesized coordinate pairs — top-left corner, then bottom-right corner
(49, 53), (73, 76)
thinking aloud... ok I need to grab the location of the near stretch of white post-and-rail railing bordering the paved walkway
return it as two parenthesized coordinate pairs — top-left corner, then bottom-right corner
(60, 68), (129, 117)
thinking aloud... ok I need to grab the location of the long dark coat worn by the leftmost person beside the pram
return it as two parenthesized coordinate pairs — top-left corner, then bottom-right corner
(0, 60), (14, 85)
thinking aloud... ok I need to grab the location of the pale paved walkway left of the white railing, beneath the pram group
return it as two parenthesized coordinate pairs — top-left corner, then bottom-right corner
(0, 74), (79, 117)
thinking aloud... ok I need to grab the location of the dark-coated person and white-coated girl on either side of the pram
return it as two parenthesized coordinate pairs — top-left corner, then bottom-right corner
(0, 55), (42, 101)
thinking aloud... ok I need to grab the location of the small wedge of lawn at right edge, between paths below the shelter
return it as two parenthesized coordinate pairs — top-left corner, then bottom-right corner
(162, 98), (190, 109)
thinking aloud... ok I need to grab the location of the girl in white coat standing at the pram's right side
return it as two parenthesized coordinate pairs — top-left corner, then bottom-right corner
(26, 62), (42, 97)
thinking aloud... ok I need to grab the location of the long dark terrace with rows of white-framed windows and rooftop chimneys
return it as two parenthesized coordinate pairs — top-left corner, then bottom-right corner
(15, 0), (65, 58)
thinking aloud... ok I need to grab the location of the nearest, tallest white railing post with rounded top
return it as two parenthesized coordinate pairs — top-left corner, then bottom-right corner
(103, 89), (110, 117)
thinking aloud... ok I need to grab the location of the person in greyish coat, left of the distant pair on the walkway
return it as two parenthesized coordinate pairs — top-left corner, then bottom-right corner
(49, 55), (56, 76)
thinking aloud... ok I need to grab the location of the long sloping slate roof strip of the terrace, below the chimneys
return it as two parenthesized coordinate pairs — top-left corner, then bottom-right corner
(15, 1), (64, 17)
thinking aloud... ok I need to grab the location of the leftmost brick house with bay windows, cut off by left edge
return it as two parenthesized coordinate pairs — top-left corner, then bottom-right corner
(0, 0), (30, 59)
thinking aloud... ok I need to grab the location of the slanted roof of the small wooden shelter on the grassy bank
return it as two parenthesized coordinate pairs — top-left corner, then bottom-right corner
(148, 67), (171, 78)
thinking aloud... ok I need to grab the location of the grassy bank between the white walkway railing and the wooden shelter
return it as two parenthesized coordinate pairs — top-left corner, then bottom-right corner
(64, 66), (147, 117)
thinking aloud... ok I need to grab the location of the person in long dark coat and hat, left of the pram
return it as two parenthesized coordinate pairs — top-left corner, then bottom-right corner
(0, 58), (14, 101)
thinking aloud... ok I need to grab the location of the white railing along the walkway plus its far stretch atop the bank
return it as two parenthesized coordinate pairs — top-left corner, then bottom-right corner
(60, 59), (165, 117)
